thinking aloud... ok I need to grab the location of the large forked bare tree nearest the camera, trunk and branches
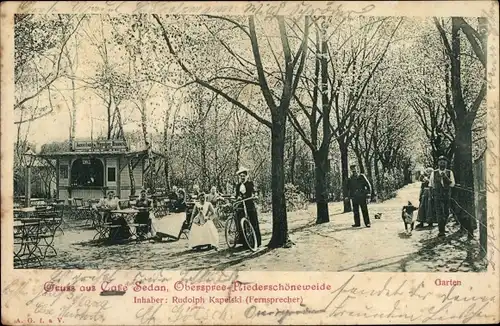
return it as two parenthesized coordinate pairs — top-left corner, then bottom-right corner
(153, 14), (310, 248)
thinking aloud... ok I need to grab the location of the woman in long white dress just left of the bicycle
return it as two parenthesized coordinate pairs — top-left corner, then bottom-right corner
(189, 193), (219, 250)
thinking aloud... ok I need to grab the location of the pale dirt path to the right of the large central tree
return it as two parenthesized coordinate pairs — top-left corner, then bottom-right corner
(235, 184), (484, 272)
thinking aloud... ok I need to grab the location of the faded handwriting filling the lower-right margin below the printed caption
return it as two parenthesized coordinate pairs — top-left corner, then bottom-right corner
(244, 275), (498, 324)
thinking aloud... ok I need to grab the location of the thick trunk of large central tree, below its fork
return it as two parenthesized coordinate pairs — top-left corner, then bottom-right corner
(267, 116), (288, 248)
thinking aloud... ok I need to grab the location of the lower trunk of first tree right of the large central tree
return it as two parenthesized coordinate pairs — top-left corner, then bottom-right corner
(314, 151), (330, 224)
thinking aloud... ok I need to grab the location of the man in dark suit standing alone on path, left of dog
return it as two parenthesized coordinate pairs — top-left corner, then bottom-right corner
(346, 164), (371, 228)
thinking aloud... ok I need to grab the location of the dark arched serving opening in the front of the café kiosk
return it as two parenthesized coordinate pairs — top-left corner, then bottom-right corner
(71, 158), (104, 187)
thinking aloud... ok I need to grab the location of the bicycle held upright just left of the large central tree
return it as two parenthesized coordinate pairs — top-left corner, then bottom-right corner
(225, 197), (258, 252)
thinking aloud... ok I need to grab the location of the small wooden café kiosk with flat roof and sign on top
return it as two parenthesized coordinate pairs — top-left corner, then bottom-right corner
(39, 140), (153, 200)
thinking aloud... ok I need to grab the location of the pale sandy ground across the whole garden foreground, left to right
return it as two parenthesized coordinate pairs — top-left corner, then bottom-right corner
(41, 184), (484, 272)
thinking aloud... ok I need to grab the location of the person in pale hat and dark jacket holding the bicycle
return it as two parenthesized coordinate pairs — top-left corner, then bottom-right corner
(236, 168), (262, 247)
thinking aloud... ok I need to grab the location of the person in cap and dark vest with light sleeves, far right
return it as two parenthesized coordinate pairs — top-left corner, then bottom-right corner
(429, 156), (455, 237)
